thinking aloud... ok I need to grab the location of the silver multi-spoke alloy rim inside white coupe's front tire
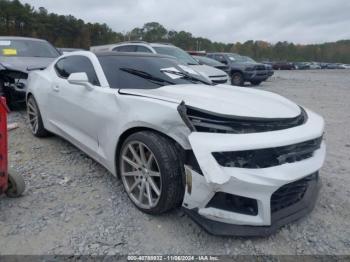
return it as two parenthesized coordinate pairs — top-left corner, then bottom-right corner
(120, 141), (162, 209)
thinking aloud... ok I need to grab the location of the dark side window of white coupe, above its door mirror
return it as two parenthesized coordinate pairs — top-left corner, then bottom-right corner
(55, 56), (100, 86)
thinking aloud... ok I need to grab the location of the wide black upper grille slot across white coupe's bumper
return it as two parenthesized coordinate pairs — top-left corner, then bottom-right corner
(213, 137), (322, 169)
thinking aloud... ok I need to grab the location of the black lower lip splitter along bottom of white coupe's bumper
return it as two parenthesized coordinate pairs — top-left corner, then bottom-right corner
(184, 174), (321, 237)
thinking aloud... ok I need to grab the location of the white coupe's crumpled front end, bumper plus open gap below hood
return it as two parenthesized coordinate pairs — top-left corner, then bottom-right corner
(178, 103), (326, 236)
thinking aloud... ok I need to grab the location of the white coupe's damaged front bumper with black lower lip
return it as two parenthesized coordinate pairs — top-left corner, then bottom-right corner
(183, 108), (326, 236)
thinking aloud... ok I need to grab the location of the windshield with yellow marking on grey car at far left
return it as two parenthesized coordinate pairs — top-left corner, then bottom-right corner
(0, 39), (60, 58)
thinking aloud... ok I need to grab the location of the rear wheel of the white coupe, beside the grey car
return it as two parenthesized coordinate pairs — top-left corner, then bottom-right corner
(27, 96), (50, 137)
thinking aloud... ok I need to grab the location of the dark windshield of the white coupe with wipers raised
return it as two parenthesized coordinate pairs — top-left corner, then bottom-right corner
(98, 56), (211, 89)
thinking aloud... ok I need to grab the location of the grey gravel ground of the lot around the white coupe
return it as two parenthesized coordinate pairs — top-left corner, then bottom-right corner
(0, 70), (350, 255)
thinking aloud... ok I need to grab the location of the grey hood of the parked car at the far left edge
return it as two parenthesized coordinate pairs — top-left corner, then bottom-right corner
(0, 57), (56, 73)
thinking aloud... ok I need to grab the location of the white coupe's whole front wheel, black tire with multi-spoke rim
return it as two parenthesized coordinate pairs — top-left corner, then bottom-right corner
(118, 131), (185, 215)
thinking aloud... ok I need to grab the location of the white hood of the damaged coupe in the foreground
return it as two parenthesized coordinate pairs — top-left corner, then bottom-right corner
(119, 84), (301, 118)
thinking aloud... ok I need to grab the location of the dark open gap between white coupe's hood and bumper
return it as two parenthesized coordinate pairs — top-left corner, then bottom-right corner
(178, 102), (307, 134)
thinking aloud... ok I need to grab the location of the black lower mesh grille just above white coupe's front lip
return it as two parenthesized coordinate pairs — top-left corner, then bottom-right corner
(271, 173), (318, 213)
